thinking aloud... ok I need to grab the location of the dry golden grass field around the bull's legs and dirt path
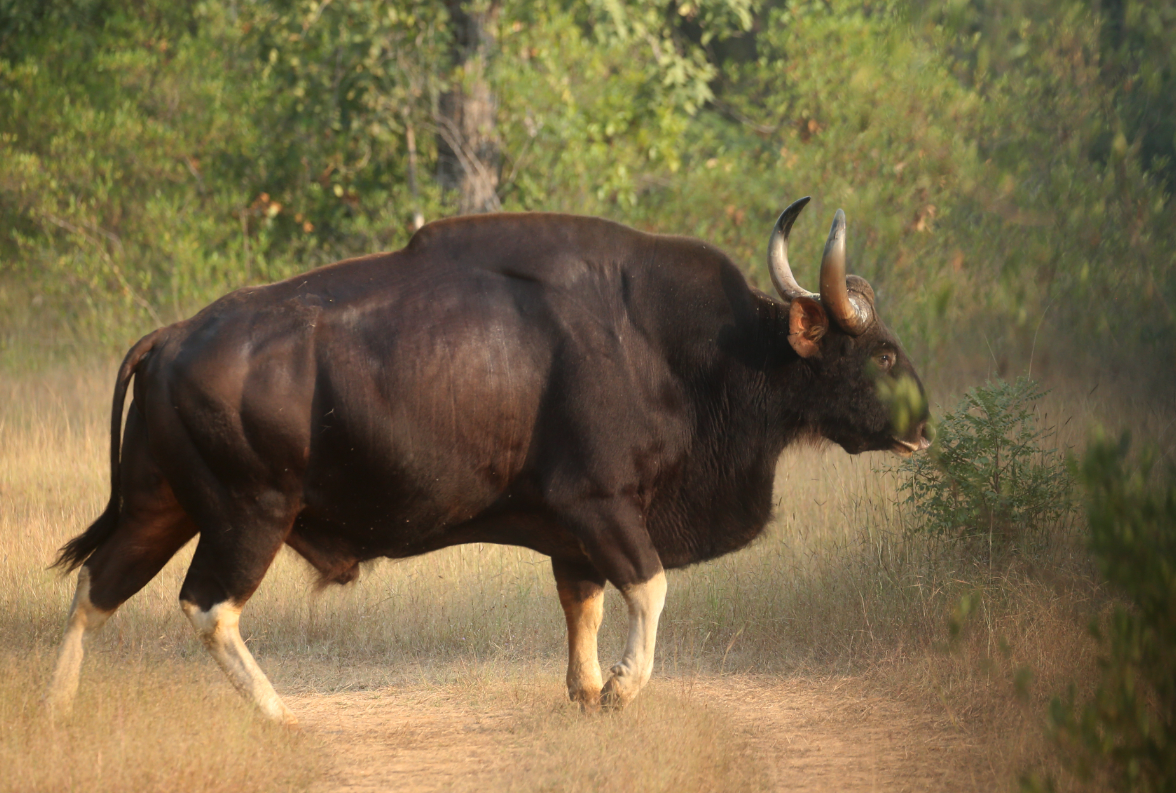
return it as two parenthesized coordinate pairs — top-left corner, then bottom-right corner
(0, 365), (1174, 791)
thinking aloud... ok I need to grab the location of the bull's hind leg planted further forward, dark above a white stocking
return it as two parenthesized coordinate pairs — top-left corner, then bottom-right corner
(180, 505), (298, 725)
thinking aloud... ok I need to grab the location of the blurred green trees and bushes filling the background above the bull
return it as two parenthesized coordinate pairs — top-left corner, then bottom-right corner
(0, 0), (1176, 372)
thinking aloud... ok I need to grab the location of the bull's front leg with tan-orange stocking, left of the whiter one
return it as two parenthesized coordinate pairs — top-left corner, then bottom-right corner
(552, 559), (604, 712)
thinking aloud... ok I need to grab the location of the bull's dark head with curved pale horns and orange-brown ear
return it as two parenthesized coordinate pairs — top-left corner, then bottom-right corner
(768, 196), (930, 454)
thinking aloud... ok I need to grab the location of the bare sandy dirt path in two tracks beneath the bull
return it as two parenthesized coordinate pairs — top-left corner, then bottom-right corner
(288, 675), (1001, 793)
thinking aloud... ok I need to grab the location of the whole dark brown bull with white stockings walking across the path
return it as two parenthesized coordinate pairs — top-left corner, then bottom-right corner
(48, 199), (927, 721)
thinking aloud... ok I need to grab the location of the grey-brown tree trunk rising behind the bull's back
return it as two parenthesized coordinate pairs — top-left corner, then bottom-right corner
(436, 0), (502, 214)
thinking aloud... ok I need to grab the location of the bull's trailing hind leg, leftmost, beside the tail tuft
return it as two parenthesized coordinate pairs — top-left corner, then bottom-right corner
(45, 408), (196, 715)
